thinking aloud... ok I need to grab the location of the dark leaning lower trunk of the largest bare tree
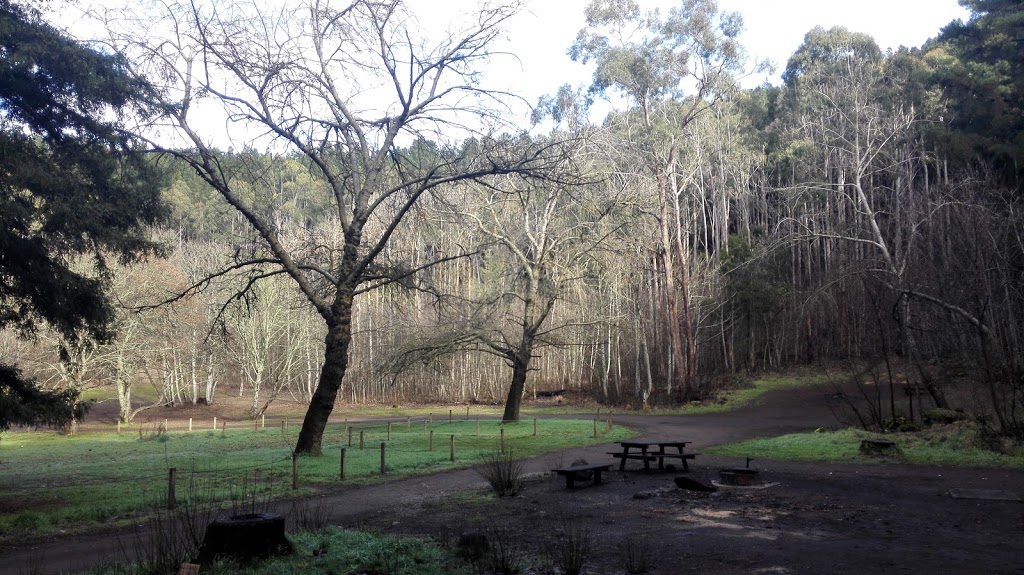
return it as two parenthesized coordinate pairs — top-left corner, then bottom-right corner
(295, 286), (353, 455)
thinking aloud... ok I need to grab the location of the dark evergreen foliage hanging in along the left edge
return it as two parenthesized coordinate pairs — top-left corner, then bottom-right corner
(0, 0), (164, 425)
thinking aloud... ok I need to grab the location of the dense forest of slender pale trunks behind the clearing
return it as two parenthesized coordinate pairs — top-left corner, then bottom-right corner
(0, 0), (1024, 435)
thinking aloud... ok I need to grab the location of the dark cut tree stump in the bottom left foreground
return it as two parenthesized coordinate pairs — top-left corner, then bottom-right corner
(199, 514), (293, 565)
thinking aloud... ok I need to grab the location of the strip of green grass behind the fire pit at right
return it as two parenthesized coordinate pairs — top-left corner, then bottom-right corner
(702, 429), (1024, 469)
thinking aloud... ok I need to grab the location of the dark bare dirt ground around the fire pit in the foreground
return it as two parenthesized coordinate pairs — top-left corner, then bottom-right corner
(348, 457), (1024, 574)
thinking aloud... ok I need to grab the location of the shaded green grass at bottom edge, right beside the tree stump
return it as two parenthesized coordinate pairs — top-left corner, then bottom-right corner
(86, 528), (470, 575)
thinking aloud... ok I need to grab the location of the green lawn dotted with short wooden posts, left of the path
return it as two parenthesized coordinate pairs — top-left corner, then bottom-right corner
(0, 417), (632, 541)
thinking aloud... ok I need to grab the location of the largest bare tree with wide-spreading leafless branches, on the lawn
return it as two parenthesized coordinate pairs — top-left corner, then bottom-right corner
(108, 0), (569, 453)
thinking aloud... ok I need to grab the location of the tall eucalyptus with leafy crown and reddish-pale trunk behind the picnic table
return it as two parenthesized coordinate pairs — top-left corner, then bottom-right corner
(569, 0), (761, 397)
